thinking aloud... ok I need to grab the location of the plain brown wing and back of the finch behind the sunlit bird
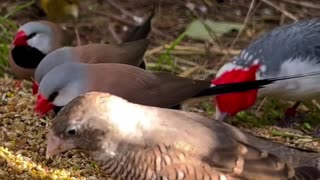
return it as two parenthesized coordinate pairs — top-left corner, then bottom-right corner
(89, 63), (210, 107)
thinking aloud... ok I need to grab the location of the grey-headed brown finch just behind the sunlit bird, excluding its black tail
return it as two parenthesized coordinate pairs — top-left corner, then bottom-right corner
(35, 63), (211, 115)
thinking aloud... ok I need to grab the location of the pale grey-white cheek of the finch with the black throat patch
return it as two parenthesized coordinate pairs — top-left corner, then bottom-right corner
(28, 33), (52, 54)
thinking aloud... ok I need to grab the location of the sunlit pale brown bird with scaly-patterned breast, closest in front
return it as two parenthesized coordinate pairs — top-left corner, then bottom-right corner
(46, 92), (320, 179)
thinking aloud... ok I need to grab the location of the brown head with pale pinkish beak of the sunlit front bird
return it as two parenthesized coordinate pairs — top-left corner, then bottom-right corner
(46, 92), (134, 157)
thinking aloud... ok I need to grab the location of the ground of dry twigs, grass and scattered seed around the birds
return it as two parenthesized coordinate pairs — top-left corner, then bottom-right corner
(0, 0), (320, 179)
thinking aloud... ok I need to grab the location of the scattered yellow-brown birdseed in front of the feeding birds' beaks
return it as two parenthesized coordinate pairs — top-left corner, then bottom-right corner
(0, 77), (107, 180)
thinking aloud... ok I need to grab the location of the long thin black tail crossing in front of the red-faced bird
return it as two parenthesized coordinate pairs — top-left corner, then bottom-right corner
(193, 71), (320, 97)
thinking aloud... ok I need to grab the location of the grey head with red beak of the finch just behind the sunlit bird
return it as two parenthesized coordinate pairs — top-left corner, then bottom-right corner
(34, 63), (86, 115)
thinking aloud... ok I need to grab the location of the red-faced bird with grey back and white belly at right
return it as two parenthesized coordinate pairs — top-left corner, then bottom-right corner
(212, 18), (320, 124)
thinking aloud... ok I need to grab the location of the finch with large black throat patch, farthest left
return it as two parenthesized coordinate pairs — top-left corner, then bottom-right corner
(8, 20), (72, 80)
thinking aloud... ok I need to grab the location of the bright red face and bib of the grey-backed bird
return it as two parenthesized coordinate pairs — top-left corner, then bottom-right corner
(211, 64), (260, 116)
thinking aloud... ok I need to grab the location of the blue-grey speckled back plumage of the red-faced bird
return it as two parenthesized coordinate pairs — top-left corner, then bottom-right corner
(234, 18), (320, 77)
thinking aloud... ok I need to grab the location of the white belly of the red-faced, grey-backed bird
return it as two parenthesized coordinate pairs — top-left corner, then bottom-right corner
(259, 58), (320, 101)
